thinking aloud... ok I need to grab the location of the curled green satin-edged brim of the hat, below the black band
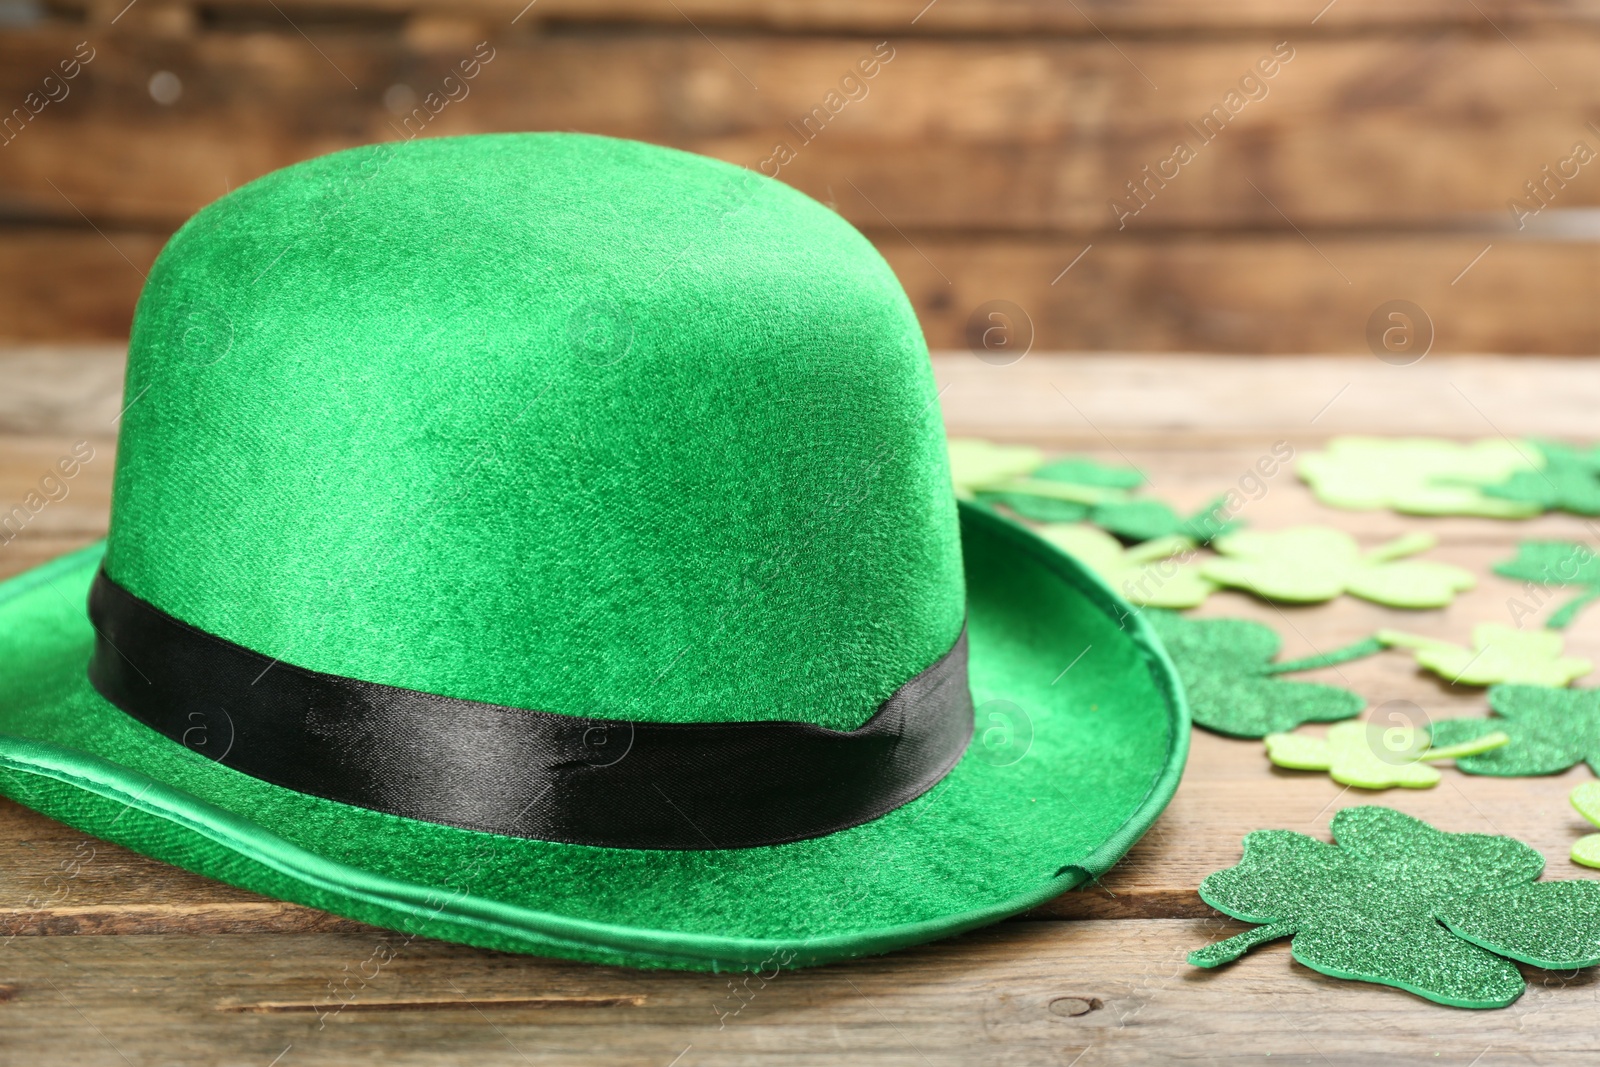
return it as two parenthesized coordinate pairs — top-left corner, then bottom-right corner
(0, 504), (1189, 969)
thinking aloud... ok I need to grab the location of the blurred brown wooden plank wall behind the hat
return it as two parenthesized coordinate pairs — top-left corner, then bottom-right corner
(0, 0), (1600, 354)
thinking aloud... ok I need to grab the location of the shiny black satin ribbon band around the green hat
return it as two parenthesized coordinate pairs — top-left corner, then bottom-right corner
(90, 571), (973, 849)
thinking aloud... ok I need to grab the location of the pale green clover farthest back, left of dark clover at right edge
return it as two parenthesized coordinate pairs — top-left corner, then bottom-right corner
(1299, 437), (1539, 518)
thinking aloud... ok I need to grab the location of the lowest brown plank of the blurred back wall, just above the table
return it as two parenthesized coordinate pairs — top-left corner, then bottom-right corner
(9, 227), (1600, 355)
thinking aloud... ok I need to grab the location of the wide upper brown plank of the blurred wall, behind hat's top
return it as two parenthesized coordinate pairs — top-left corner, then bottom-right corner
(9, 29), (1600, 231)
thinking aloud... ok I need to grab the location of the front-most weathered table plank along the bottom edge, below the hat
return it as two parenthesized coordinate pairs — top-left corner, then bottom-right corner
(0, 920), (1595, 1067)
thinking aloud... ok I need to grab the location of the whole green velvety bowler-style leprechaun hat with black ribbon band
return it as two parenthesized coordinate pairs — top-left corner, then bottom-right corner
(0, 134), (1189, 968)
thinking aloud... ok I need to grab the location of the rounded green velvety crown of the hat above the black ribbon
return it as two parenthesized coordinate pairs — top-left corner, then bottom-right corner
(116, 134), (963, 729)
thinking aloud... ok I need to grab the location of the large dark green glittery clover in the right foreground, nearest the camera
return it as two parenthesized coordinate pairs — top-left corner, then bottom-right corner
(1189, 806), (1600, 1008)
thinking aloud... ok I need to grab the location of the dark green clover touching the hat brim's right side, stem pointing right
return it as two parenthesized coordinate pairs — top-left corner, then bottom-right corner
(1147, 611), (1382, 737)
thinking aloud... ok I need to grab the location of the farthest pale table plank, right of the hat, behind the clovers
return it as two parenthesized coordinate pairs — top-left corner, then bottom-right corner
(933, 355), (1600, 441)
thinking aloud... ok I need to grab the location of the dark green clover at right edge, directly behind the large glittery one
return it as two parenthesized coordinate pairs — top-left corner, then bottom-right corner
(1434, 685), (1600, 777)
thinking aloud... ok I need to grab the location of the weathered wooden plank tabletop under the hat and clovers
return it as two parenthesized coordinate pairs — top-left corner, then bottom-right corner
(0, 347), (1600, 1067)
